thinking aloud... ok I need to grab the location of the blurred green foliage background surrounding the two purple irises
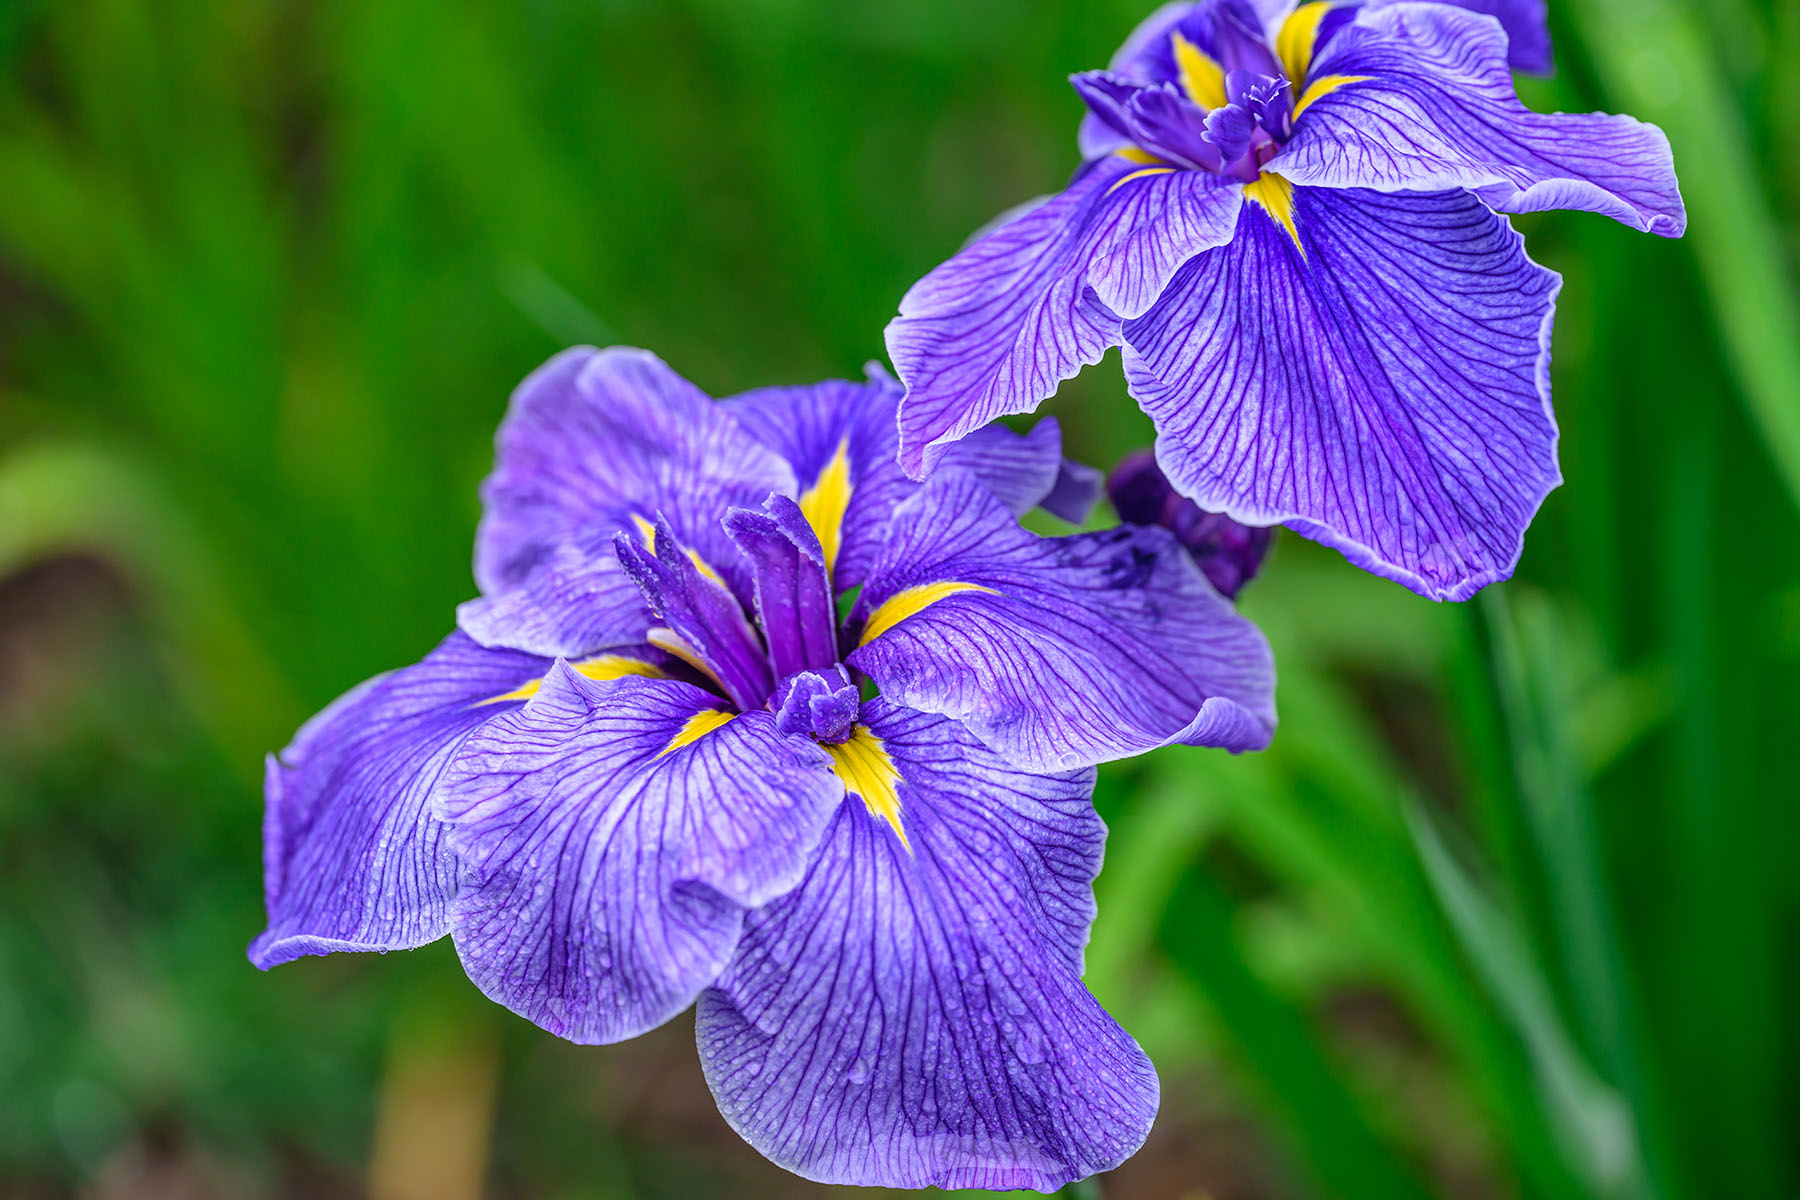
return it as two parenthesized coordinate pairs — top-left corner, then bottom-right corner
(0, 0), (1800, 1200)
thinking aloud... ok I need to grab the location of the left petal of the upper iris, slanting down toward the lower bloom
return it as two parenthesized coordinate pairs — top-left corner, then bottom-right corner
(887, 158), (1242, 477)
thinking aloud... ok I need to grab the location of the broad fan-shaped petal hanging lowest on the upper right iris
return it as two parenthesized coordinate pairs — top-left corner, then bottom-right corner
(1125, 187), (1561, 599)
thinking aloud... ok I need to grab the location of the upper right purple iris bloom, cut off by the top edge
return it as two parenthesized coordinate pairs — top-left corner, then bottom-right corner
(887, 0), (1687, 599)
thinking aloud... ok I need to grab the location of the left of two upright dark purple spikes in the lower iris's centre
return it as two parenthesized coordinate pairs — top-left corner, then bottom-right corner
(612, 522), (774, 709)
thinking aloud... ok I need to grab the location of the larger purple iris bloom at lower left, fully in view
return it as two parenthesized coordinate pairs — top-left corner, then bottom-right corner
(250, 349), (1274, 1189)
